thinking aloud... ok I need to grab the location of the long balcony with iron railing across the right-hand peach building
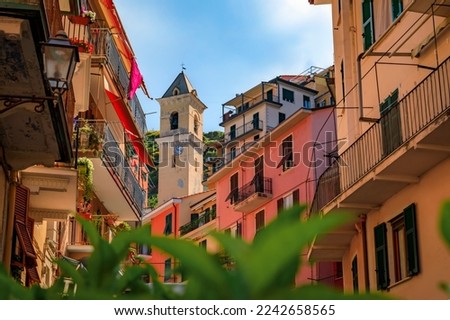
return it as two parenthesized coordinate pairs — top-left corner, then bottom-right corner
(310, 55), (450, 260)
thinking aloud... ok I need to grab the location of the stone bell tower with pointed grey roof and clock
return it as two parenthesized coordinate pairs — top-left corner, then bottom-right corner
(157, 71), (206, 204)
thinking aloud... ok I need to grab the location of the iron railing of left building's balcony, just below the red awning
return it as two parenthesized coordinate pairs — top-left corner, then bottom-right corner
(74, 120), (145, 214)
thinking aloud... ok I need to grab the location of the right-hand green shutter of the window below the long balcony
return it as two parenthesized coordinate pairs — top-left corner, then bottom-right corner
(403, 203), (420, 276)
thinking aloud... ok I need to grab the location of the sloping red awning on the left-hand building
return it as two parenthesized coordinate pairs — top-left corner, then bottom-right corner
(105, 89), (155, 168)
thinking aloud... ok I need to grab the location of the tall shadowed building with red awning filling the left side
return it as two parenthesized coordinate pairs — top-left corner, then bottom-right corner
(0, 0), (152, 286)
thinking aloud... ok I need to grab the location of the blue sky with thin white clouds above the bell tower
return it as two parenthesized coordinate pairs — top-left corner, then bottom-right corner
(114, 0), (333, 132)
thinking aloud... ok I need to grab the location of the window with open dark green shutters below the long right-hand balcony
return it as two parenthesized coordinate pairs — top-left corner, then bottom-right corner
(374, 204), (420, 290)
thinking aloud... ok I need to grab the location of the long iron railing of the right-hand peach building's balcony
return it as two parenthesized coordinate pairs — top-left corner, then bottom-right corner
(311, 58), (450, 212)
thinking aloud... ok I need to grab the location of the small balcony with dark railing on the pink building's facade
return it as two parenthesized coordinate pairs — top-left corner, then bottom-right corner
(233, 176), (272, 213)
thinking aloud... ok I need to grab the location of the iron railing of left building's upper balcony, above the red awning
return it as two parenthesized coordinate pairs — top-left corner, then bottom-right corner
(90, 28), (147, 135)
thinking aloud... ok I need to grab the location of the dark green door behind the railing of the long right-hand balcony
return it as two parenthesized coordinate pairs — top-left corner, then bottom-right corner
(380, 90), (402, 157)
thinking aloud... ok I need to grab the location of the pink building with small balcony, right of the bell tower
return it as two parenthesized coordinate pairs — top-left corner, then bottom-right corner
(205, 107), (339, 283)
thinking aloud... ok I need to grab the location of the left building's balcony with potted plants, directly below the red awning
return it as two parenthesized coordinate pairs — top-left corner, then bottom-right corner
(74, 121), (145, 221)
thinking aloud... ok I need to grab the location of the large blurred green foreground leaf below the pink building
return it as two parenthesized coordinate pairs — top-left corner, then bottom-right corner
(242, 206), (351, 299)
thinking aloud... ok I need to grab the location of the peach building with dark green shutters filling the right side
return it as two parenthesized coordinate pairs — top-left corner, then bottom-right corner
(309, 0), (450, 299)
